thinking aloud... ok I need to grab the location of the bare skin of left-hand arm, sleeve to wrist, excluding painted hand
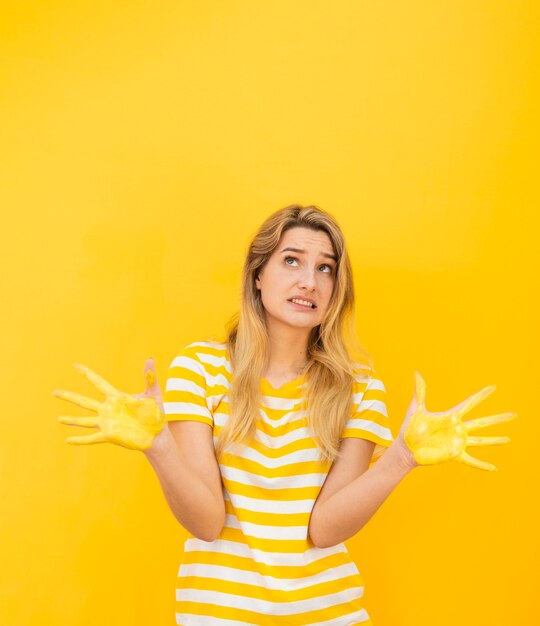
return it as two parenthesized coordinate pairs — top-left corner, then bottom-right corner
(144, 421), (225, 541)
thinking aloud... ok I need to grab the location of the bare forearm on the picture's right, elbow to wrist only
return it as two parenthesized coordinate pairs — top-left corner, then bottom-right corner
(309, 443), (414, 548)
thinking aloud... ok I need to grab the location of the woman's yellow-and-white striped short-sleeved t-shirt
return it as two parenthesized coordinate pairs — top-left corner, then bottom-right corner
(164, 341), (393, 626)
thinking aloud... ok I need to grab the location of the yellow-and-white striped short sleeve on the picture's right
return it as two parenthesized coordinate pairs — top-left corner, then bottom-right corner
(341, 372), (394, 462)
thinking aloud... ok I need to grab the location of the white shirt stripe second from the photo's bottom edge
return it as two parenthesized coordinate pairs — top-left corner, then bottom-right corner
(176, 587), (363, 615)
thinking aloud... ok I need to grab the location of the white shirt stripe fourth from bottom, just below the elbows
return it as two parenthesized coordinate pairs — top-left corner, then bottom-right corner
(184, 537), (348, 567)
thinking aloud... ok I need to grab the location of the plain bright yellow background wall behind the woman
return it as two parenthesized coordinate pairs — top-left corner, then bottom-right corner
(0, 0), (540, 626)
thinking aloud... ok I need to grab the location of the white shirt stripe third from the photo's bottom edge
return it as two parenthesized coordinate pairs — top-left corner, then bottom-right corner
(178, 563), (363, 591)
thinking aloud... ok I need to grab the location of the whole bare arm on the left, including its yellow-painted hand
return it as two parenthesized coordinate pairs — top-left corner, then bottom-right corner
(53, 359), (225, 541)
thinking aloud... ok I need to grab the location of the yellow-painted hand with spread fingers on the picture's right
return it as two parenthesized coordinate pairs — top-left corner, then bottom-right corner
(398, 372), (517, 471)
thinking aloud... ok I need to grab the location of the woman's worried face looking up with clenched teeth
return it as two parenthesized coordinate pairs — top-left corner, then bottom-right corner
(256, 226), (337, 330)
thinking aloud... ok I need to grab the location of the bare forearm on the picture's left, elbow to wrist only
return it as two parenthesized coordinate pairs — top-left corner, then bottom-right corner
(144, 429), (225, 541)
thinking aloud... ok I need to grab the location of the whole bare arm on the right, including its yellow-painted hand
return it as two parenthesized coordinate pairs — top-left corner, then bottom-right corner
(309, 372), (517, 548)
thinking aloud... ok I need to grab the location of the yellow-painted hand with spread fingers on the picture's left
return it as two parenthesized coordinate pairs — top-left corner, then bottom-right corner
(52, 359), (165, 450)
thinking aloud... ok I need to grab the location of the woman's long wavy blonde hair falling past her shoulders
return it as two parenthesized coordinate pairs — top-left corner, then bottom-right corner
(216, 204), (372, 461)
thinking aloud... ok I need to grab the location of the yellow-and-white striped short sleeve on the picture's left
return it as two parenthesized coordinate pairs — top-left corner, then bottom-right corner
(163, 344), (214, 427)
